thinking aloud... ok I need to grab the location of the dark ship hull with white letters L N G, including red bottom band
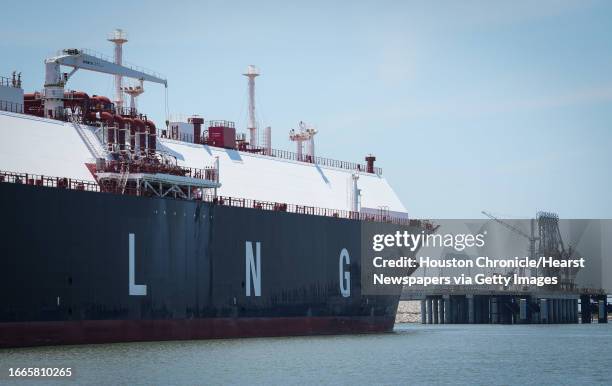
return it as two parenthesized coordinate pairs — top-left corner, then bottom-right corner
(0, 183), (412, 347)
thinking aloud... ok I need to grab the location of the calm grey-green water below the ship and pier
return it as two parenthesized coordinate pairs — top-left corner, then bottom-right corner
(0, 324), (612, 385)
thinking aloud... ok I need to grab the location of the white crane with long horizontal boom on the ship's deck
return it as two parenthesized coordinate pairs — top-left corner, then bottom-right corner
(43, 49), (168, 118)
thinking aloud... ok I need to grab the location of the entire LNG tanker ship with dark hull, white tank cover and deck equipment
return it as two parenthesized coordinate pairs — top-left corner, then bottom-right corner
(0, 30), (428, 347)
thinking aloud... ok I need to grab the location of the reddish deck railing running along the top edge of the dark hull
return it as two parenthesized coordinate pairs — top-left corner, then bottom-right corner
(0, 171), (426, 230)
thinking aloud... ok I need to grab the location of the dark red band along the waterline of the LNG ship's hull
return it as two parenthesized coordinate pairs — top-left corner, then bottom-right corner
(0, 317), (394, 348)
